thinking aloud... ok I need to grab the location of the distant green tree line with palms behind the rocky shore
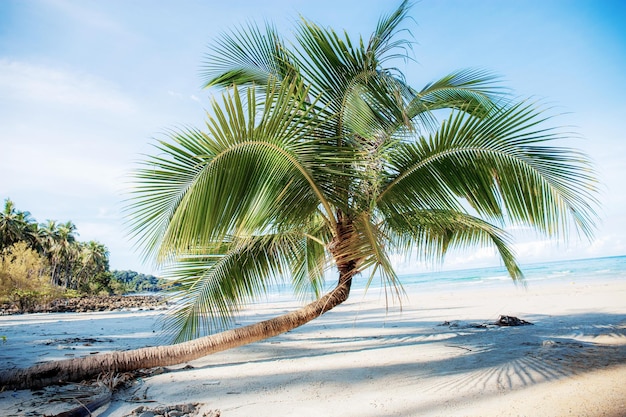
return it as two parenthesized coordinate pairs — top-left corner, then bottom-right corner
(0, 198), (163, 309)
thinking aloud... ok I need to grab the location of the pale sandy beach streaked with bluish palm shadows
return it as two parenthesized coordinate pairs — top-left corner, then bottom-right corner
(0, 280), (626, 417)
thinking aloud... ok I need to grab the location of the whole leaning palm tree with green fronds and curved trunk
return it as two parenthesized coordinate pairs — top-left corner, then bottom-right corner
(0, 1), (595, 386)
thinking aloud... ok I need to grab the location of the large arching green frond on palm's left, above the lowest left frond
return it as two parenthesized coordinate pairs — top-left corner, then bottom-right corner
(129, 79), (338, 260)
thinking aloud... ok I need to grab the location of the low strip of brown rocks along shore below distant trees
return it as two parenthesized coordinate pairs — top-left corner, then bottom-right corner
(0, 295), (167, 315)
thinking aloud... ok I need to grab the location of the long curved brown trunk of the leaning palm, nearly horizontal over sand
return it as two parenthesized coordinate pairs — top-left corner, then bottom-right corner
(0, 268), (354, 390)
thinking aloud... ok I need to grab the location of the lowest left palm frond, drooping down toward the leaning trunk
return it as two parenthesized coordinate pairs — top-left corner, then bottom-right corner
(165, 228), (329, 342)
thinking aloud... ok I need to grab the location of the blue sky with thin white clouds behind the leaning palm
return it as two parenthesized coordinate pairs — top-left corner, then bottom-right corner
(0, 0), (626, 273)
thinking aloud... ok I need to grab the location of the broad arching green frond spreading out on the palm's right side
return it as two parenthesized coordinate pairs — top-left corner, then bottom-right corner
(378, 102), (595, 239)
